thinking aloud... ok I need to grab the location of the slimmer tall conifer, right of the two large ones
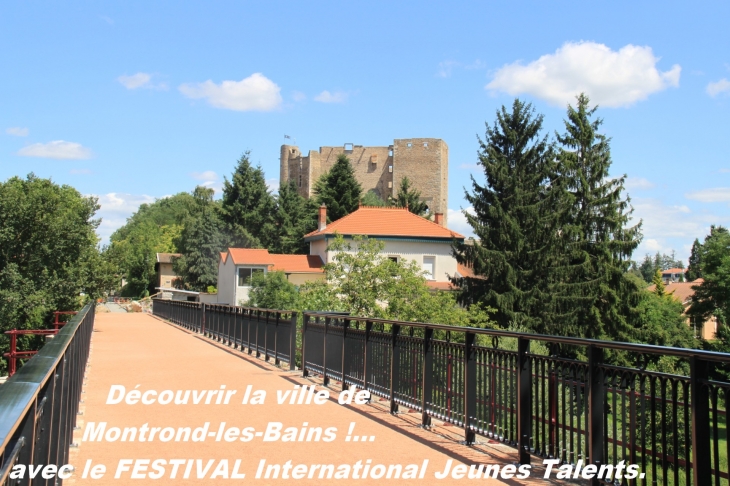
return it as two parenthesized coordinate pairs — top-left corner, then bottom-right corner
(556, 94), (641, 339)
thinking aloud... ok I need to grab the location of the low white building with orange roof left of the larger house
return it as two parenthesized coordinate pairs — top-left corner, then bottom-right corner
(218, 248), (324, 305)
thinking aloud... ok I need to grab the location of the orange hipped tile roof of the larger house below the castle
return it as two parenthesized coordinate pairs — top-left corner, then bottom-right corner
(304, 206), (464, 239)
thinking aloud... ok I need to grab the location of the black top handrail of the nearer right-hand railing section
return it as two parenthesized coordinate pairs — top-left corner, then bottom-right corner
(302, 311), (730, 363)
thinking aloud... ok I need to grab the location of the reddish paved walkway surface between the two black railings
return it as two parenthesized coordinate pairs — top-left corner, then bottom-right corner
(71, 314), (545, 485)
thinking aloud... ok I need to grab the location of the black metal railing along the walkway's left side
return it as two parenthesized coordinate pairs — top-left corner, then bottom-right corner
(0, 304), (95, 485)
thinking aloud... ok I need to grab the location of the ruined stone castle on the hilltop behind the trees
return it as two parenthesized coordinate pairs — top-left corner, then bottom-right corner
(279, 138), (449, 224)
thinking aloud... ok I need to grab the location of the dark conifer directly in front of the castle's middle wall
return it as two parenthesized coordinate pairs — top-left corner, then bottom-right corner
(314, 154), (362, 221)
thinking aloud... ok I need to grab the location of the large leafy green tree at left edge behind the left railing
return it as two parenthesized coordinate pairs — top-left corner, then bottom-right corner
(0, 174), (113, 372)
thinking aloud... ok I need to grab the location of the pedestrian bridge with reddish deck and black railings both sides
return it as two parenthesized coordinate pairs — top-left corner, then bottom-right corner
(0, 301), (730, 485)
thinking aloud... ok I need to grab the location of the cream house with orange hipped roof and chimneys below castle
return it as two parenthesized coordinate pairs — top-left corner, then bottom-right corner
(304, 206), (471, 290)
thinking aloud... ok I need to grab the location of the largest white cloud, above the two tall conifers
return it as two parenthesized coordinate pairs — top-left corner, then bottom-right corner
(486, 42), (682, 107)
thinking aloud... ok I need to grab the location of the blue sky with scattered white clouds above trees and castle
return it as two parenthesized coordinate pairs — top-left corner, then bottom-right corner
(0, 1), (730, 259)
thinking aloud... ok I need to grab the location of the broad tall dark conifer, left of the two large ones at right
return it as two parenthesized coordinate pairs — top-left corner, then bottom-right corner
(454, 100), (562, 332)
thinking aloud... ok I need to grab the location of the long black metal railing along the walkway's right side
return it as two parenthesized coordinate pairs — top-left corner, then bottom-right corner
(155, 301), (730, 486)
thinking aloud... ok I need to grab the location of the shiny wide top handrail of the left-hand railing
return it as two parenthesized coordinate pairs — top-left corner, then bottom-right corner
(0, 303), (94, 451)
